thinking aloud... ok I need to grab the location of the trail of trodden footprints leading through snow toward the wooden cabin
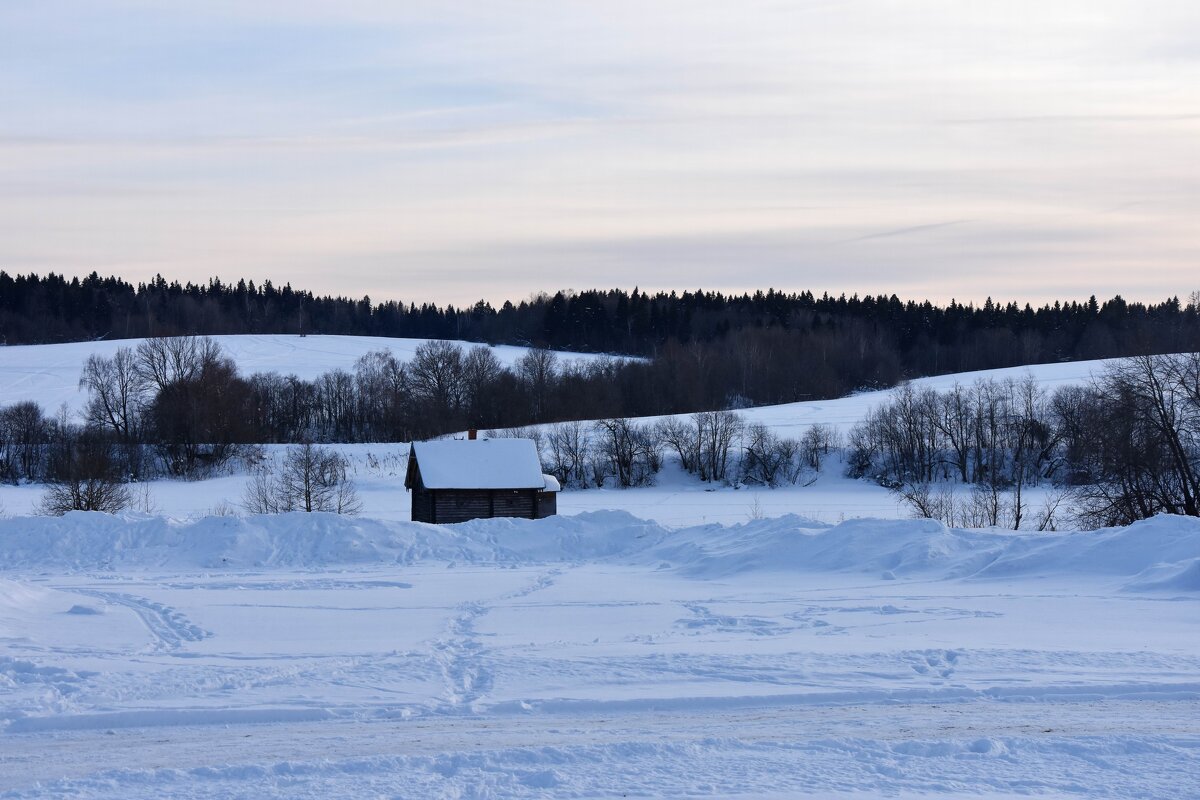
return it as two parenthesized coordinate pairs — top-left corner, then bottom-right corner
(433, 569), (563, 711)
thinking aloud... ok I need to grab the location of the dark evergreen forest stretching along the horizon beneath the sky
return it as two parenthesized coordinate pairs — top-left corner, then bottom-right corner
(0, 271), (1200, 381)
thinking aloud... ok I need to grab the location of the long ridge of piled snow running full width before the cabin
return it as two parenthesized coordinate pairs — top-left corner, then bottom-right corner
(0, 511), (1200, 587)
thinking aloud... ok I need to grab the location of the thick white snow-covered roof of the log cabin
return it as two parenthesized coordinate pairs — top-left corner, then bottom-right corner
(413, 439), (546, 489)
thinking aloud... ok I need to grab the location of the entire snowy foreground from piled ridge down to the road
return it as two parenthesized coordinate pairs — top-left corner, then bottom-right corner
(0, 511), (1200, 798)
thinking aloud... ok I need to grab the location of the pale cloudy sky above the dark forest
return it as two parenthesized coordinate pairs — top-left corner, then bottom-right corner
(0, 0), (1200, 305)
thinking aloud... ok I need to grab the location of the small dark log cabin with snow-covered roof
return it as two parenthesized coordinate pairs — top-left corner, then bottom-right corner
(404, 439), (559, 524)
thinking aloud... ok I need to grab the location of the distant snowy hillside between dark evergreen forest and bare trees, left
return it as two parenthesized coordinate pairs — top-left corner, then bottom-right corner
(0, 333), (619, 414)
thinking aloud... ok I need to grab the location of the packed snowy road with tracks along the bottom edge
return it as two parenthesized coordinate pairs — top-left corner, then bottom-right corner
(0, 699), (1200, 800)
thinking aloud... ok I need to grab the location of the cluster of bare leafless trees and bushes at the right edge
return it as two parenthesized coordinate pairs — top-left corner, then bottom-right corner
(847, 353), (1200, 528)
